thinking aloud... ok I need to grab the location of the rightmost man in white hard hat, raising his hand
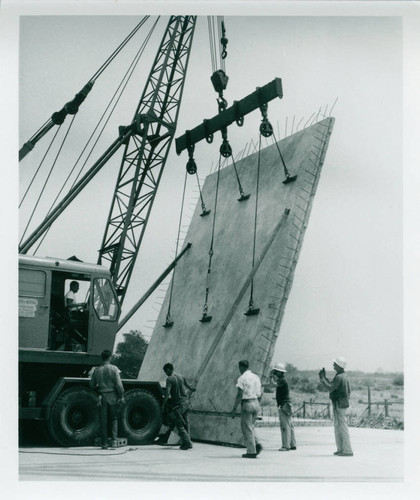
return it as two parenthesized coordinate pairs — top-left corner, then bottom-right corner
(319, 356), (353, 457)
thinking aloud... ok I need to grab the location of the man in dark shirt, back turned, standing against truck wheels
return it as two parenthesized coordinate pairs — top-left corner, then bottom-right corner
(89, 350), (124, 450)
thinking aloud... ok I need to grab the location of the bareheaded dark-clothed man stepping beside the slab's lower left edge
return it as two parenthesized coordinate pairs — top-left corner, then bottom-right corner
(162, 363), (195, 450)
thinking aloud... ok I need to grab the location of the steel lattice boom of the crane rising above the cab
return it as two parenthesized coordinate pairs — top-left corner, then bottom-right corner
(98, 16), (196, 303)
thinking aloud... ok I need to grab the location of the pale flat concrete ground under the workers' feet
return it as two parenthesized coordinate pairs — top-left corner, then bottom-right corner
(19, 420), (404, 482)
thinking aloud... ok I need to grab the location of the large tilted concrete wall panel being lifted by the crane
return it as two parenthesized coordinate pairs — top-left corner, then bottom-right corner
(139, 118), (334, 444)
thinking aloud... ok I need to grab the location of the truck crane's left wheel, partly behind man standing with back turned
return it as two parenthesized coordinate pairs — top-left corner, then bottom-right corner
(47, 387), (100, 446)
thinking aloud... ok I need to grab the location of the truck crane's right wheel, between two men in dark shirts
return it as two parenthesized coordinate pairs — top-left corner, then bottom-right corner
(118, 389), (162, 444)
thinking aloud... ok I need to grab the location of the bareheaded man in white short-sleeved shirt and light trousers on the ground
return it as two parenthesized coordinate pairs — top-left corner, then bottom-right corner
(232, 360), (262, 458)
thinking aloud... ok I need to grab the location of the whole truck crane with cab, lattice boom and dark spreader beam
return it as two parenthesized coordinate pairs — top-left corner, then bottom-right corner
(19, 16), (281, 446)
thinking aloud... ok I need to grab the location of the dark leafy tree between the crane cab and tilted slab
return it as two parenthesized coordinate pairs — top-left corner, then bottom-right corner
(112, 330), (149, 378)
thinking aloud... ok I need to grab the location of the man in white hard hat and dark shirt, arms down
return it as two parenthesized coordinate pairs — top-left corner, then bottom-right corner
(271, 363), (296, 451)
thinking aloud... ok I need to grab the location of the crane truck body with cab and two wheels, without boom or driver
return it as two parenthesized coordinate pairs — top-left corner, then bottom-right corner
(19, 255), (162, 446)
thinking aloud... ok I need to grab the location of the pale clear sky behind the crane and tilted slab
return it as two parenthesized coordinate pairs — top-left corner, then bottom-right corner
(15, 11), (403, 371)
